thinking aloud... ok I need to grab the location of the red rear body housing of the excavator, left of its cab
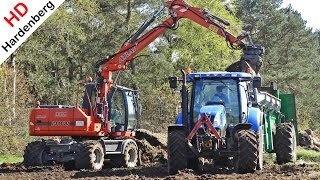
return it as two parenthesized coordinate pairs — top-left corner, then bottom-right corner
(29, 108), (105, 136)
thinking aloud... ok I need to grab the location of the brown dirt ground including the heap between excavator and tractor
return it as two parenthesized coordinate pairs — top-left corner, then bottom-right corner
(0, 131), (320, 180)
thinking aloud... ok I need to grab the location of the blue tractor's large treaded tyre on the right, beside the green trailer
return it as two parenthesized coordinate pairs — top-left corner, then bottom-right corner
(235, 130), (258, 173)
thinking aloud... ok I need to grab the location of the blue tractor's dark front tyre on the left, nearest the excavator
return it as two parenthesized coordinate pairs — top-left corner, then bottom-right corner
(168, 130), (188, 174)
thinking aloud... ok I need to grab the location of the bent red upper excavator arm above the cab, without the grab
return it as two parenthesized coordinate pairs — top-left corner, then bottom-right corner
(99, 0), (249, 76)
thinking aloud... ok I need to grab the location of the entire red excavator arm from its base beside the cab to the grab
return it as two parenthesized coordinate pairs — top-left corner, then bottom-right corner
(97, 0), (262, 122)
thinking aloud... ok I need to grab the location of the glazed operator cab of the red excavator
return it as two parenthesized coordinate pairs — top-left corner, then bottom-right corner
(108, 86), (141, 132)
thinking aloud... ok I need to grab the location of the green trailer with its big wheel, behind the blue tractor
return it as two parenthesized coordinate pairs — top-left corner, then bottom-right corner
(253, 83), (298, 163)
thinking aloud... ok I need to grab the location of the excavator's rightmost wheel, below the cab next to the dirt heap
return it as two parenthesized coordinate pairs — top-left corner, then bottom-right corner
(110, 142), (138, 167)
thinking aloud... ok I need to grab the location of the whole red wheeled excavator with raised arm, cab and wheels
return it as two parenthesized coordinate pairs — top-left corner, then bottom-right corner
(24, 0), (261, 170)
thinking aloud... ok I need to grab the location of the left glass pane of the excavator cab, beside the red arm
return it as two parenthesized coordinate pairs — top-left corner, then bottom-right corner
(110, 90), (126, 125)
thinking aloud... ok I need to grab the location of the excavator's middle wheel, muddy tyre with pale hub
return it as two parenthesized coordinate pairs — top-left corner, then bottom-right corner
(74, 141), (104, 170)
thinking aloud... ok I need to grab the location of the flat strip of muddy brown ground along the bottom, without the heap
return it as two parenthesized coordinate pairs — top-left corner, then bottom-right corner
(0, 162), (320, 180)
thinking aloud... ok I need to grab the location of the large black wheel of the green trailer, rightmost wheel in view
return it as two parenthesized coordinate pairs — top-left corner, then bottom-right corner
(274, 123), (297, 164)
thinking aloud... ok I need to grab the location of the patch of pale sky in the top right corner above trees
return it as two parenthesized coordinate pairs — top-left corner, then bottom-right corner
(282, 0), (320, 30)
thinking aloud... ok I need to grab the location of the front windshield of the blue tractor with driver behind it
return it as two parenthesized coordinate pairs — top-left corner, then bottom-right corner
(193, 79), (240, 124)
